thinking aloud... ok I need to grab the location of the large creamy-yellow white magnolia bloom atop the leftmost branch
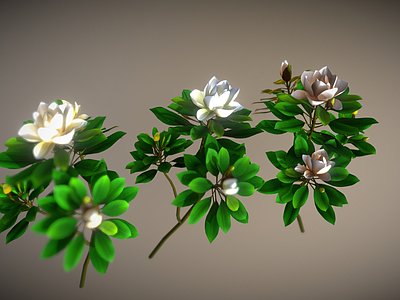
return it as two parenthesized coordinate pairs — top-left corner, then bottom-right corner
(18, 100), (88, 159)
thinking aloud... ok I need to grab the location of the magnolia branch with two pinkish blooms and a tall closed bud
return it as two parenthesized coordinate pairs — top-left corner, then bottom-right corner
(256, 61), (378, 231)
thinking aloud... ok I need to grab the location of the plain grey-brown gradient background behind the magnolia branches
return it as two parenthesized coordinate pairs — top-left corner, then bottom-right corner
(0, 1), (400, 300)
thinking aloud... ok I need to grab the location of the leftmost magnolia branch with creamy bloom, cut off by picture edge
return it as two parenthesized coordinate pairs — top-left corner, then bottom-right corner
(0, 100), (138, 287)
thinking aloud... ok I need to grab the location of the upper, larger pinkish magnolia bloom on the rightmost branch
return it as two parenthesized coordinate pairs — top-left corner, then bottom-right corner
(292, 67), (348, 110)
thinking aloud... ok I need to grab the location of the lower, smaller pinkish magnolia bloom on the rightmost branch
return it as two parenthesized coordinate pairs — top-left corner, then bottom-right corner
(294, 149), (335, 181)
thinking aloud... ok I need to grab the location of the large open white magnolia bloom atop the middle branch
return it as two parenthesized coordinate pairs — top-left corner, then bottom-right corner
(190, 76), (243, 121)
